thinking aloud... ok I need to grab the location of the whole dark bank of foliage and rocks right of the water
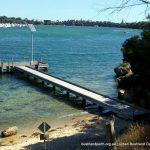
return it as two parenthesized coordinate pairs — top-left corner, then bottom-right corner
(114, 30), (150, 110)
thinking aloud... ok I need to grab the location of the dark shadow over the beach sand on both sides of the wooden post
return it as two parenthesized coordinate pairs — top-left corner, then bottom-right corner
(24, 116), (129, 150)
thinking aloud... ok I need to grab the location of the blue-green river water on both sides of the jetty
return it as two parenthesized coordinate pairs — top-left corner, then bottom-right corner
(0, 26), (140, 129)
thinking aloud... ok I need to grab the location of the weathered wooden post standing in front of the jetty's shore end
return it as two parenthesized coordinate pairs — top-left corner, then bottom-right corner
(106, 116), (116, 150)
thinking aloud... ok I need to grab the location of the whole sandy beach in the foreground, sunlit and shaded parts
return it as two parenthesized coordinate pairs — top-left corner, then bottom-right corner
(0, 113), (130, 150)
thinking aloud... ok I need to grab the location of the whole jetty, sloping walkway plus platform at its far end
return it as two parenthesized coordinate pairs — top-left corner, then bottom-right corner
(0, 61), (150, 119)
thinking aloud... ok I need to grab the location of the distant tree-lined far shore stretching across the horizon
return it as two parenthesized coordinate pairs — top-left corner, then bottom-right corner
(0, 16), (150, 29)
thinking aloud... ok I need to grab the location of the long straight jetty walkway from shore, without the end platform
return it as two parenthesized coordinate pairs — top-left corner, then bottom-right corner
(15, 66), (150, 119)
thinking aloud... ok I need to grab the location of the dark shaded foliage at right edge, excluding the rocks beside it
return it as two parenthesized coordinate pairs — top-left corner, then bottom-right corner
(121, 30), (150, 108)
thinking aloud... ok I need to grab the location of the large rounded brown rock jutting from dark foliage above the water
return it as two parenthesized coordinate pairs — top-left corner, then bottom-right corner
(114, 63), (131, 76)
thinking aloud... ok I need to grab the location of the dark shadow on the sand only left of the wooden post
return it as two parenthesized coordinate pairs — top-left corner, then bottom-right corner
(24, 117), (106, 150)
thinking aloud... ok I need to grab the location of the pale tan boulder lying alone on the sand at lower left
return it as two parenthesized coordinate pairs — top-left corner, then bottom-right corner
(1, 126), (18, 137)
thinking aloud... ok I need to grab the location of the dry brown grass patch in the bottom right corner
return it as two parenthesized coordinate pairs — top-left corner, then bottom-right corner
(116, 123), (150, 150)
